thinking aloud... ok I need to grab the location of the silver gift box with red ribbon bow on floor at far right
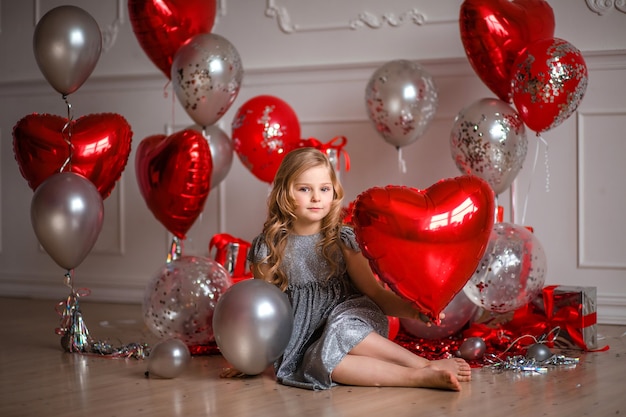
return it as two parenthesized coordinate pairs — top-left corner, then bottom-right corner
(533, 285), (598, 350)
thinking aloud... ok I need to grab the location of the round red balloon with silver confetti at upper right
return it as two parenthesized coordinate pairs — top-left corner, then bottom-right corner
(512, 38), (588, 133)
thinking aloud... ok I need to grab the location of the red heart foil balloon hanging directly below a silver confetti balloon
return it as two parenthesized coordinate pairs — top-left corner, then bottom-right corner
(135, 129), (213, 239)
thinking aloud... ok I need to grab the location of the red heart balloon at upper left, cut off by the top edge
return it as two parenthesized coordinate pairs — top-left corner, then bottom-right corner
(128, 0), (216, 79)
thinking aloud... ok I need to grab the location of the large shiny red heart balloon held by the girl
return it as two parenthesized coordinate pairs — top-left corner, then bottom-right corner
(352, 176), (495, 322)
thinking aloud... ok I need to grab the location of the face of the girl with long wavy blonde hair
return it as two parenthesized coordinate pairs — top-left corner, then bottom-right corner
(291, 165), (334, 235)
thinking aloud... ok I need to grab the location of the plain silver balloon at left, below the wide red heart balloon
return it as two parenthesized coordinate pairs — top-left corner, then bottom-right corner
(30, 172), (104, 270)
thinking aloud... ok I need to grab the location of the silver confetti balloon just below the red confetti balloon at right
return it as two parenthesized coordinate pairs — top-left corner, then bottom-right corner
(450, 98), (528, 195)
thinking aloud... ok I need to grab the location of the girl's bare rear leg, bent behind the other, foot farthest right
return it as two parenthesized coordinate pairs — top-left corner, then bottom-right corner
(348, 332), (472, 382)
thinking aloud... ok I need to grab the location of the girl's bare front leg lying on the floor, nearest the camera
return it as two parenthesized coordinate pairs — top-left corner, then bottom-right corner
(332, 354), (461, 391)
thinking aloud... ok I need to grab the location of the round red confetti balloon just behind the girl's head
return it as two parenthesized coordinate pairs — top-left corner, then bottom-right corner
(232, 95), (301, 183)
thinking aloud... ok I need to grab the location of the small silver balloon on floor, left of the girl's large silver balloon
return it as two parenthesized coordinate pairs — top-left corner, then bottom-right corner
(147, 339), (191, 378)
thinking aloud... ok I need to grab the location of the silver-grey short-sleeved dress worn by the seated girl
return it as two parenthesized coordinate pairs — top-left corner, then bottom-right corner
(248, 227), (388, 390)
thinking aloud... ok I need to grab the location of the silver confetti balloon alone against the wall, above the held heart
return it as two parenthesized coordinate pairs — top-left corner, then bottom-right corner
(365, 59), (438, 148)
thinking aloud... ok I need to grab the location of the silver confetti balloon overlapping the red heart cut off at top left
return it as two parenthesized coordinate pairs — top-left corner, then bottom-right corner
(171, 33), (243, 126)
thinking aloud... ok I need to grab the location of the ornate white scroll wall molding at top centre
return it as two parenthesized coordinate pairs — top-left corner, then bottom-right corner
(265, 0), (457, 33)
